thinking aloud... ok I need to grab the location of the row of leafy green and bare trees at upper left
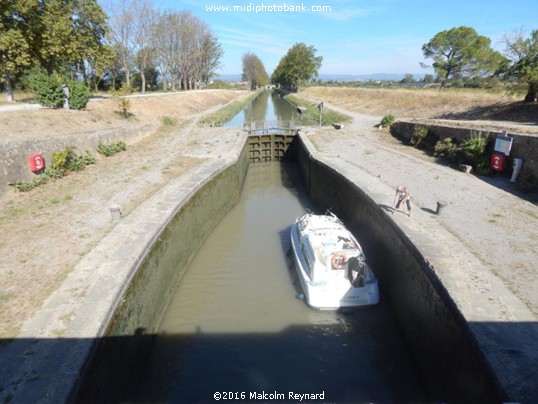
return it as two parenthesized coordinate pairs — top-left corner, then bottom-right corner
(0, 0), (223, 101)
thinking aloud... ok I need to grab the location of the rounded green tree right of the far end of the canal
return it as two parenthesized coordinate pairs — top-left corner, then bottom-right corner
(271, 43), (323, 91)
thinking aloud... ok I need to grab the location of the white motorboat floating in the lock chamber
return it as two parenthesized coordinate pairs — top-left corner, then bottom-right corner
(291, 213), (379, 310)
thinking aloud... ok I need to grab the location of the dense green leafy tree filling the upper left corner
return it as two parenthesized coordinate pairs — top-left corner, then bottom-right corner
(0, 0), (108, 100)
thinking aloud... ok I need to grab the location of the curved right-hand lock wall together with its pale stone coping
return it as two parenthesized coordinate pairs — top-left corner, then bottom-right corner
(296, 134), (536, 403)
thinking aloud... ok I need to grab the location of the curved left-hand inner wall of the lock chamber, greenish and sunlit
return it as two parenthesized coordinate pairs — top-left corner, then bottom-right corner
(74, 139), (248, 402)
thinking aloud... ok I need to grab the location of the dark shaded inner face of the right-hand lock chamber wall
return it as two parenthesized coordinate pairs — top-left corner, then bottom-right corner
(296, 136), (503, 402)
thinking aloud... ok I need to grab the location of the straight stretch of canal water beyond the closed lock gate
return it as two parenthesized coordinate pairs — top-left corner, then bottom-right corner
(224, 90), (314, 127)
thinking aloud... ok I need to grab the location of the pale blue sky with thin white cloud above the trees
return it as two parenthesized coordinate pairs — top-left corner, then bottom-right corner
(149, 0), (538, 75)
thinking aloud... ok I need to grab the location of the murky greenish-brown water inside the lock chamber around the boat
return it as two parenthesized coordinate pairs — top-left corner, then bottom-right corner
(133, 163), (424, 402)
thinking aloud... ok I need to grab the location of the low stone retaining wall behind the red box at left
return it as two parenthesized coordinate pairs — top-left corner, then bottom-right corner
(0, 125), (152, 195)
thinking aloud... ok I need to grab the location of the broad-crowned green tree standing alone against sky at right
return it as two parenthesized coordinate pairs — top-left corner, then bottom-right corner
(422, 27), (502, 88)
